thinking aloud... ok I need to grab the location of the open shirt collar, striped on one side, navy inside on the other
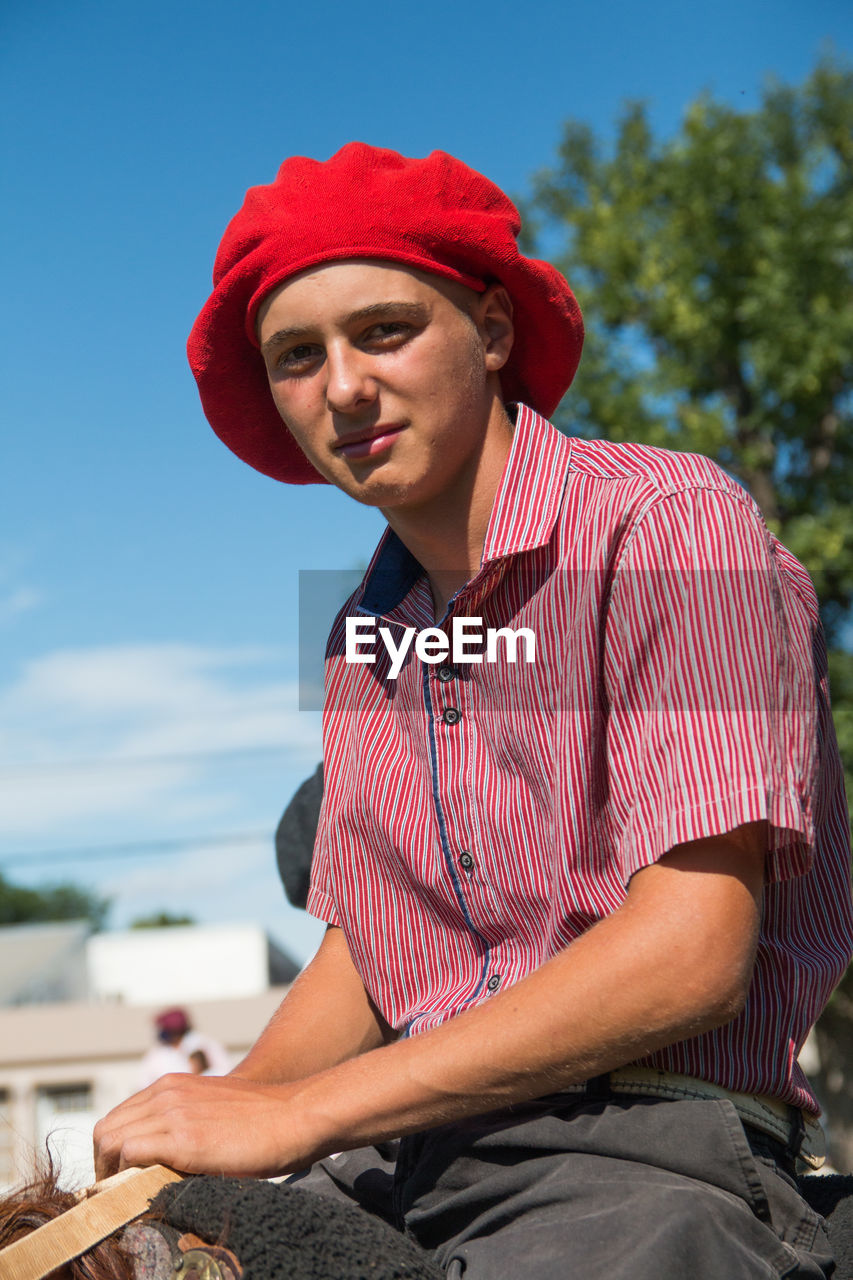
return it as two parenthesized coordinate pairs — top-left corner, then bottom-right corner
(359, 404), (571, 625)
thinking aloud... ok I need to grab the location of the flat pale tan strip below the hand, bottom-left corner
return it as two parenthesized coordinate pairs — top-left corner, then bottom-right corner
(0, 1165), (183, 1280)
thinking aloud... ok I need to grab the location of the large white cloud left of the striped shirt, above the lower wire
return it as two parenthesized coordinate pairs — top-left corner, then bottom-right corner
(0, 644), (320, 844)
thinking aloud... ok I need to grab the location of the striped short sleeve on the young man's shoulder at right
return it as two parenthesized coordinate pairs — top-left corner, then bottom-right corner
(603, 488), (817, 883)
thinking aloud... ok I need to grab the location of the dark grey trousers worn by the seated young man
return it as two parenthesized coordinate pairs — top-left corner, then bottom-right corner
(292, 1094), (834, 1280)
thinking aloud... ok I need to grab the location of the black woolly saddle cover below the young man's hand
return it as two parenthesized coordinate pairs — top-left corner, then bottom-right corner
(152, 1178), (441, 1280)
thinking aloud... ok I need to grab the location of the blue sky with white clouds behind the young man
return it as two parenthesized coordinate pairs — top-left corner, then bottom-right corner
(0, 0), (853, 957)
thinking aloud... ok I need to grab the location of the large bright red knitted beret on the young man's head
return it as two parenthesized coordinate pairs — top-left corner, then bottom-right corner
(187, 142), (583, 484)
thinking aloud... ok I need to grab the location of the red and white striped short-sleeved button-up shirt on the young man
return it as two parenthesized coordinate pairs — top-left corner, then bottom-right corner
(309, 406), (853, 1111)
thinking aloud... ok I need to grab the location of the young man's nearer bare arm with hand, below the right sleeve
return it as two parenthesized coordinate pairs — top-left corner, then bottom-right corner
(95, 823), (766, 1176)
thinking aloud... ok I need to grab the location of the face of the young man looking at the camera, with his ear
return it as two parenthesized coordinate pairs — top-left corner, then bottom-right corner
(257, 261), (512, 509)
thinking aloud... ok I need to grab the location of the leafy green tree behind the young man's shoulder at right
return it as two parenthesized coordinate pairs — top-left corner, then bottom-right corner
(529, 56), (853, 1169)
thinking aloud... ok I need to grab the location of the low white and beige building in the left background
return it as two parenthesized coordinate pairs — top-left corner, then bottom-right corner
(0, 923), (297, 1189)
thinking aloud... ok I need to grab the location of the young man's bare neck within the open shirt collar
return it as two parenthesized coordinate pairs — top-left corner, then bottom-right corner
(383, 406), (512, 621)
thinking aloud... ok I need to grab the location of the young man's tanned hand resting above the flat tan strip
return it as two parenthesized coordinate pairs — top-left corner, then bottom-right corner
(95, 1074), (308, 1179)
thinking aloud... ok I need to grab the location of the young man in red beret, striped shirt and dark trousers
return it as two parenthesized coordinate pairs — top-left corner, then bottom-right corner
(96, 145), (853, 1280)
